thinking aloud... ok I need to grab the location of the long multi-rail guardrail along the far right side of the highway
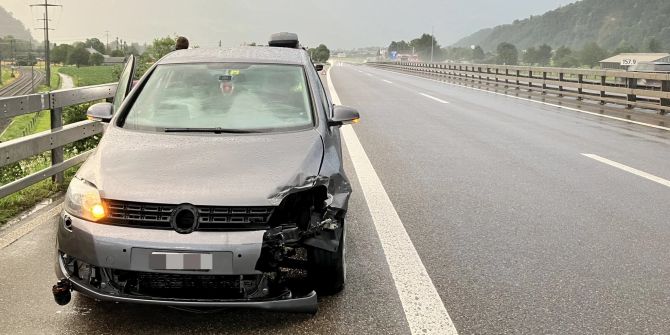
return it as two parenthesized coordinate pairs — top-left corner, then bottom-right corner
(367, 62), (670, 115)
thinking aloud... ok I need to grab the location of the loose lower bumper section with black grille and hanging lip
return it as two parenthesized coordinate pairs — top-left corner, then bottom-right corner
(53, 254), (318, 314)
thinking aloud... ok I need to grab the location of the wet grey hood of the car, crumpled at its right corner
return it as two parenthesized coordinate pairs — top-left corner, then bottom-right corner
(77, 126), (323, 206)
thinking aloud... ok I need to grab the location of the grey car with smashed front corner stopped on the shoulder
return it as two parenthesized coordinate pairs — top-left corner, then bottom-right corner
(53, 34), (359, 313)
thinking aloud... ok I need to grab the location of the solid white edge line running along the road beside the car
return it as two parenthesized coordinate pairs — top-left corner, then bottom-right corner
(326, 65), (458, 335)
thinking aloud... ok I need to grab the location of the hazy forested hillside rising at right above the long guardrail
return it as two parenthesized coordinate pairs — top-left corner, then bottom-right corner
(454, 0), (670, 51)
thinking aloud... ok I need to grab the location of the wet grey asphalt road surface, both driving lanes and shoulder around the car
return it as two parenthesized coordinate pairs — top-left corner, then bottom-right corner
(0, 65), (670, 334)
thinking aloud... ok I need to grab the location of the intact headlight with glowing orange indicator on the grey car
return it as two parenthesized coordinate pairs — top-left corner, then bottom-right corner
(65, 177), (105, 221)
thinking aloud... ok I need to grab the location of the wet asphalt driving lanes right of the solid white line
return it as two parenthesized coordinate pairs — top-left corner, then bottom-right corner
(332, 62), (670, 334)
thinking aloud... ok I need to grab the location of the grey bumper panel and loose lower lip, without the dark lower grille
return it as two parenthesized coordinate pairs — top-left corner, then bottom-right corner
(56, 212), (318, 314)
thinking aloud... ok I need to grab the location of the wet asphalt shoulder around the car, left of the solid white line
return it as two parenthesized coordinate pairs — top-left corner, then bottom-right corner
(0, 152), (409, 335)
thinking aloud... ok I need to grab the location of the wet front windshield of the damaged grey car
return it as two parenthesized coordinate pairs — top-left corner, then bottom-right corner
(122, 63), (314, 132)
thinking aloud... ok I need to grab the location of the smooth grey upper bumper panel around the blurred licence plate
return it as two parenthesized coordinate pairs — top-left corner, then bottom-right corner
(57, 212), (265, 275)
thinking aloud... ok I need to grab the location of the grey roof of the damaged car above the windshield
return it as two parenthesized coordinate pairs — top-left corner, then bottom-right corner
(158, 46), (310, 65)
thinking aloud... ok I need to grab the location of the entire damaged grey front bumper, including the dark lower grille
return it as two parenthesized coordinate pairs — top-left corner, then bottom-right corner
(54, 217), (318, 314)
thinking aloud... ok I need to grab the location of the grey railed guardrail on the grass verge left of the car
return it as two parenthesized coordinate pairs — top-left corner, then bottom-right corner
(0, 84), (116, 198)
